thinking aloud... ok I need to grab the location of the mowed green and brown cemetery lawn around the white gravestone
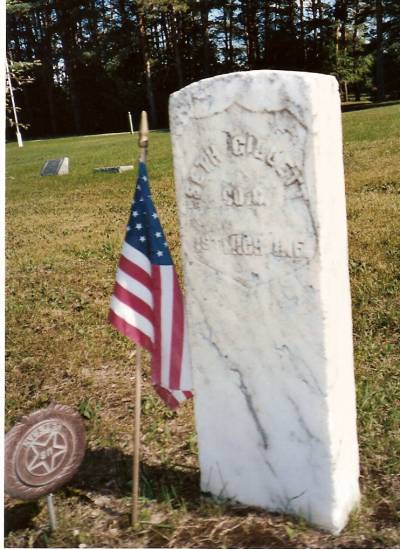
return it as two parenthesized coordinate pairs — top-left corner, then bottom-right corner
(6, 105), (400, 548)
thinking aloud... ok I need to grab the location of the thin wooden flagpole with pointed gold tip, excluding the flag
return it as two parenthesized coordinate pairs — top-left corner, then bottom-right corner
(132, 111), (149, 527)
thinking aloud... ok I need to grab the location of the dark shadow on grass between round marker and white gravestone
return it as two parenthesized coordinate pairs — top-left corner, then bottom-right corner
(70, 448), (200, 505)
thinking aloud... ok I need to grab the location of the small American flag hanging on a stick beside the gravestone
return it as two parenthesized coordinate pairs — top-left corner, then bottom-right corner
(108, 162), (192, 409)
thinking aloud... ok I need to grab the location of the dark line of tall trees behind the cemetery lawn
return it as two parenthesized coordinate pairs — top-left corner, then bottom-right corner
(6, 0), (400, 136)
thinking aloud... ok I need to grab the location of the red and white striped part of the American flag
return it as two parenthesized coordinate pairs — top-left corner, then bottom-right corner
(109, 241), (192, 409)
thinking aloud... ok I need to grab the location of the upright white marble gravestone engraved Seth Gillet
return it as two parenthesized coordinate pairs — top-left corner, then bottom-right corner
(170, 71), (359, 533)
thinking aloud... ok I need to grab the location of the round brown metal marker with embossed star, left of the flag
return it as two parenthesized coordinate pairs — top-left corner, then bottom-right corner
(4, 403), (86, 500)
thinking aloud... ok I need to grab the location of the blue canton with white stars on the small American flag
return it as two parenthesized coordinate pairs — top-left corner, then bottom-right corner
(125, 162), (172, 265)
